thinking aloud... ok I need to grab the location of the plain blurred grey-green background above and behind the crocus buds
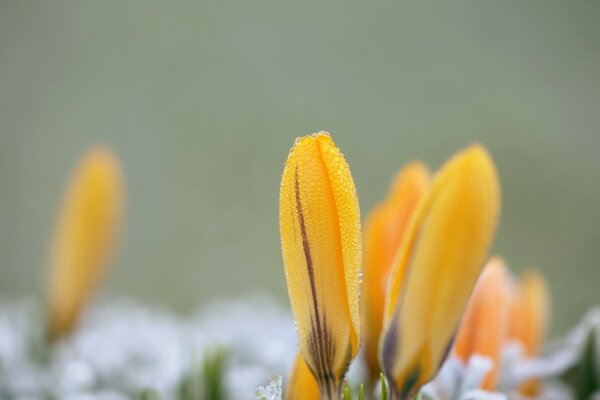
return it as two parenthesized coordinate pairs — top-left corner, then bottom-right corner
(0, 0), (600, 334)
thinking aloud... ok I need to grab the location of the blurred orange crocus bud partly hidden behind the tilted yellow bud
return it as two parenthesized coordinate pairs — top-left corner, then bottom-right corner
(362, 162), (430, 377)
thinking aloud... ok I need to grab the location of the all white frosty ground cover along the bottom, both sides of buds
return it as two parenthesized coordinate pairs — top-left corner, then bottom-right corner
(0, 298), (600, 400)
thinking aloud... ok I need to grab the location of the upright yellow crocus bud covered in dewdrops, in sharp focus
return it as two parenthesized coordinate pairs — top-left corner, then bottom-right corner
(279, 132), (361, 399)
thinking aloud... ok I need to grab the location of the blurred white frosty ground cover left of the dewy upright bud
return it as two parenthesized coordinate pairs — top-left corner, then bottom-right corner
(0, 299), (296, 400)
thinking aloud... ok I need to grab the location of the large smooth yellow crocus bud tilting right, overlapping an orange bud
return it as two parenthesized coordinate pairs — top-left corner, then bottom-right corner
(380, 146), (500, 400)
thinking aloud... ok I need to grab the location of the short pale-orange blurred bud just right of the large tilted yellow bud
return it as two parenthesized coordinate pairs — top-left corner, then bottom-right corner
(454, 257), (512, 391)
